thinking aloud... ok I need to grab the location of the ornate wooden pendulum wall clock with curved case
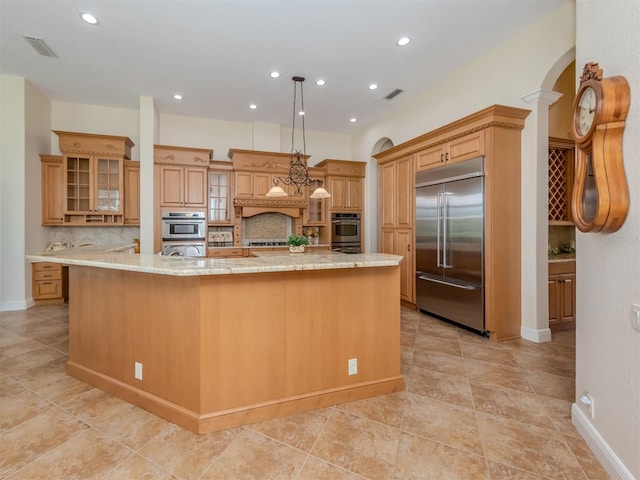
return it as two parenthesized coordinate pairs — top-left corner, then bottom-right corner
(571, 62), (630, 233)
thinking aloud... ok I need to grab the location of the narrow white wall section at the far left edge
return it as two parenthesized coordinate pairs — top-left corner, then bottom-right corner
(0, 75), (31, 311)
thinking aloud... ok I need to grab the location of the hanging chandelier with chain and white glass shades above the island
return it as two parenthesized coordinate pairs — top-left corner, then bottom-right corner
(267, 76), (331, 198)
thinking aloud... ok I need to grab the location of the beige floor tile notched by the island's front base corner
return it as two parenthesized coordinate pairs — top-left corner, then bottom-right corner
(138, 425), (242, 479)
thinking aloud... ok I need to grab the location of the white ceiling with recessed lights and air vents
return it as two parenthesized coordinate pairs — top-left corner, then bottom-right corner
(0, 0), (573, 134)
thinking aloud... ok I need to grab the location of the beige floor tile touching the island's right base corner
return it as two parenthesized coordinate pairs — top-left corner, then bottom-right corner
(408, 366), (473, 408)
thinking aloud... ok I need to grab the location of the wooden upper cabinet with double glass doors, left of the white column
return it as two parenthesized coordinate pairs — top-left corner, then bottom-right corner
(54, 130), (133, 225)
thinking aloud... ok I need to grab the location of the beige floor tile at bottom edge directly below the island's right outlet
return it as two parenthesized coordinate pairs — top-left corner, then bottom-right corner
(311, 410), (400, 480)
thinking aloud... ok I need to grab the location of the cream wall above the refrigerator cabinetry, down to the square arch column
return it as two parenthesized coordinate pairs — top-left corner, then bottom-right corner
(353, 4), (575, 337)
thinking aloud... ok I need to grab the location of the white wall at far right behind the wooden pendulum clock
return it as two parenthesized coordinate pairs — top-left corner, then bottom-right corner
(574, 0), (640, 478)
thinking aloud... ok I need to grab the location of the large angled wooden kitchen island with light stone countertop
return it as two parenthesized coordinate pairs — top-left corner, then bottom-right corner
(27, 248), (403, 433)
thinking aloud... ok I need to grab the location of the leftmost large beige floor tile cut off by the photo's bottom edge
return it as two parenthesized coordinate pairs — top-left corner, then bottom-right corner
(11, 429), (133, 480)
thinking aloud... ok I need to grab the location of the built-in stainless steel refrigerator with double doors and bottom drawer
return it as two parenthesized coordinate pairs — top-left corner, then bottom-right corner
(415, 157), (487, 335)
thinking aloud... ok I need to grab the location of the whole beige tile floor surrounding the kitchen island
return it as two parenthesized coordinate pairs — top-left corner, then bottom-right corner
(0, 305), (609, 480)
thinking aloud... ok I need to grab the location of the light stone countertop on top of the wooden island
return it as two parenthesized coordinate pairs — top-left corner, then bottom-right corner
(26, 246), (402, 276)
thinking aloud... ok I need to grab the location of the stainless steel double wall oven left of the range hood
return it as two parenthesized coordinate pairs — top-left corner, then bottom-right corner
(160, 211), (207, 257)
